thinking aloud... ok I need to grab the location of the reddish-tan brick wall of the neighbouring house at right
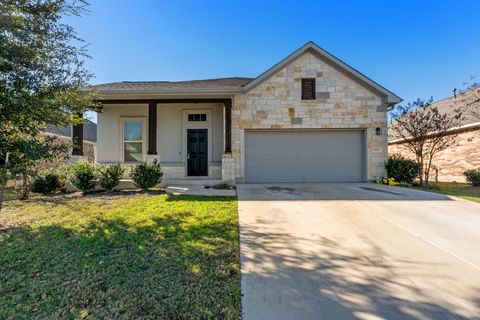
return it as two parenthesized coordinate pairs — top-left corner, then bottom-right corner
(388, 128), (480, 182)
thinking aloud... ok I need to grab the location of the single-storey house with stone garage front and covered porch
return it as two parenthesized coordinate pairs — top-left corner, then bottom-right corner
(74, 42), (401, 183)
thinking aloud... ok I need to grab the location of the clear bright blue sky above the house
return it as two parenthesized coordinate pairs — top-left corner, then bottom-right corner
(67, 0), (480, 120)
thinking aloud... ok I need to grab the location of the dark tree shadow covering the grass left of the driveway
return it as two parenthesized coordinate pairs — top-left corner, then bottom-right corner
(0, 212), (240, 319)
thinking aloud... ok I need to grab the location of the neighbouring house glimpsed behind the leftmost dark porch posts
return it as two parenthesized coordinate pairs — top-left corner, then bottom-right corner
(46, 119), (97, 163)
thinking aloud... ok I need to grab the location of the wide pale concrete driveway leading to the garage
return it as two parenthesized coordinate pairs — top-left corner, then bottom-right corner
(237, 184), (480, 320)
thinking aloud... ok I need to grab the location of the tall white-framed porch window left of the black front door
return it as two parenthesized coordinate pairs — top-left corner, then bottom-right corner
(123, 120), (143, 162)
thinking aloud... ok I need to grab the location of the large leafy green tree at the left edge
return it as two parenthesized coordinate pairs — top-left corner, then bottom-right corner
(0, 0), (96, 202)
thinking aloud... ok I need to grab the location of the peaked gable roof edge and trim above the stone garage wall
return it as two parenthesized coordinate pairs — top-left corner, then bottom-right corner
(244, 41), (402, 105)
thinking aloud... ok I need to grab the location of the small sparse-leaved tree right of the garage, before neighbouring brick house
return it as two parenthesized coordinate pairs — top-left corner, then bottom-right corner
(390, 99), (462, 185)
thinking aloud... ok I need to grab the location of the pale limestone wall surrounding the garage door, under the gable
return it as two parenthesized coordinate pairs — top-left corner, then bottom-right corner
(232, 52), (387, 181)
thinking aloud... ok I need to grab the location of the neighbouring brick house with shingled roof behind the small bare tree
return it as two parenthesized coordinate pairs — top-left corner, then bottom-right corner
(388, 88), (480, 182)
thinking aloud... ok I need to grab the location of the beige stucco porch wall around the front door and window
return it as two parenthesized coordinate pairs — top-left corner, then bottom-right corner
(97, 103), (224, 178)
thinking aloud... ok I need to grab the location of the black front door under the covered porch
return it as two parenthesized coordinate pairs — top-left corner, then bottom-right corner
(187, 129), (208, 176)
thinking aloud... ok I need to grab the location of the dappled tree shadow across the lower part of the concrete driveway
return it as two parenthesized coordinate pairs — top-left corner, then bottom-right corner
(241, 225), (480, 320)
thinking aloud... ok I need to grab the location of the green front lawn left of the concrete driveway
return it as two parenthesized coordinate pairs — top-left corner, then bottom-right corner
(0, 194), (240, 319)
